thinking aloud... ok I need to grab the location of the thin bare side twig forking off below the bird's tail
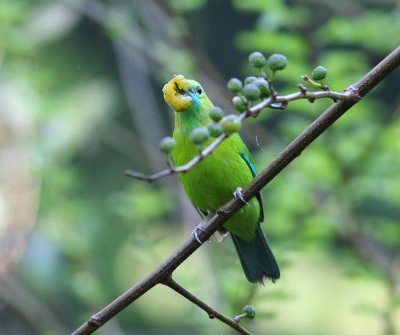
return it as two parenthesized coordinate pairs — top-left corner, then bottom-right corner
(163, 277), (252, 335)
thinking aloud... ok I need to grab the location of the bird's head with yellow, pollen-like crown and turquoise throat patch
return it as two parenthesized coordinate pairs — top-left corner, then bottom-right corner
(163, 75), (208, 112)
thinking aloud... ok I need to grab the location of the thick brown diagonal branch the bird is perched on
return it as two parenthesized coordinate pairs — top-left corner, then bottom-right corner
(72, 47), (400, 335)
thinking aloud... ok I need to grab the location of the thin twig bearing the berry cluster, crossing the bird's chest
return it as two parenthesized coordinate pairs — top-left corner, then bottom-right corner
(125, 86), (355, 182)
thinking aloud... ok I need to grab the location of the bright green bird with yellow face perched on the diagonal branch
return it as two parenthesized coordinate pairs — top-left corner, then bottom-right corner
(163, 75), (280, 283)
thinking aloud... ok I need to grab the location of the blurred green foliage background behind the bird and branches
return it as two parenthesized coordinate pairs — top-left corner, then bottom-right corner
(0, 0), (400, 335)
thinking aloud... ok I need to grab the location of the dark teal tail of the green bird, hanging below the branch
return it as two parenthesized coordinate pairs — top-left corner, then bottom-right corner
(231, 225), (280, 283)
